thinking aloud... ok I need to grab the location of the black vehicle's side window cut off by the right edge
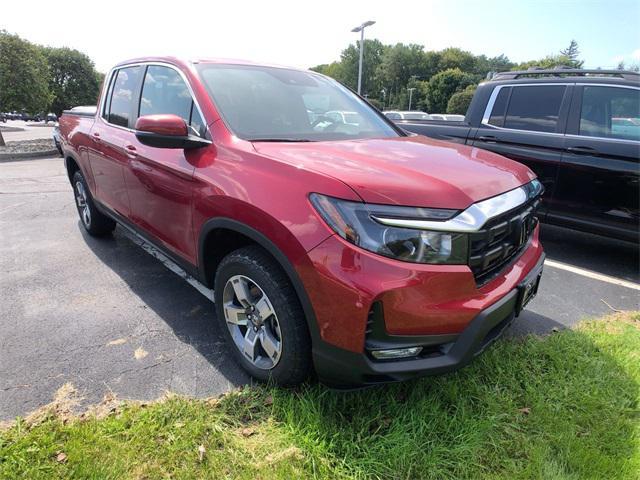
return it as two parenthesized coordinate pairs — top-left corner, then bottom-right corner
(580, 86), (640, 140)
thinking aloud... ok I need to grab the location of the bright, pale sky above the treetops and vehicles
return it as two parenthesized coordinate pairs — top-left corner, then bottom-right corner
(0, 0), (640, 72)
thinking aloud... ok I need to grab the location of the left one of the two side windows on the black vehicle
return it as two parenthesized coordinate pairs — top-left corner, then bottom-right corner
(501, 85), (566, 132)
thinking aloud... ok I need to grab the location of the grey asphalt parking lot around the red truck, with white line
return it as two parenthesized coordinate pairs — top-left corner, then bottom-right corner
(0, 158), (640, 420)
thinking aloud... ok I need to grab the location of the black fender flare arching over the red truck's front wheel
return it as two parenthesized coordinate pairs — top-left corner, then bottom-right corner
(198, 217), (320, 346)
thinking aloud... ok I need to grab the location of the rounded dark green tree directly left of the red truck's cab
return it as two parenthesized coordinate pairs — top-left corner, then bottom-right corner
(44, 47), (100, 116)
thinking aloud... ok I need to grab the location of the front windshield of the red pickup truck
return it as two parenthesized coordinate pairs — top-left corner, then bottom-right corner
(197, 64), (400, 141)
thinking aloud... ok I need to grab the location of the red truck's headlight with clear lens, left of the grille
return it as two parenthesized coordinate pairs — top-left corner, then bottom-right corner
(309, 193), (468, 265)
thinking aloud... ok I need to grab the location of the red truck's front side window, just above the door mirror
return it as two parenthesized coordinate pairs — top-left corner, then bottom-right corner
(140, 65), (204, 135)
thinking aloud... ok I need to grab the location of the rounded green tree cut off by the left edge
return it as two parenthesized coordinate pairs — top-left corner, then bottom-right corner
(0, 30), (51, 113)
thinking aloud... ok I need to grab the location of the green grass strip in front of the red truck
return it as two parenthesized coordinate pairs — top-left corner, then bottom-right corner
(0, 313), (640, 480)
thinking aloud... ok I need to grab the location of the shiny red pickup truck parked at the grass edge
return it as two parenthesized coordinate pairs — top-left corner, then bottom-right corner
(60, 57), (544, 386)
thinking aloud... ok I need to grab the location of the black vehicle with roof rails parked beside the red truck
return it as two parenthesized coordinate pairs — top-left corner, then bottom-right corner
(397, 69), (640, 242)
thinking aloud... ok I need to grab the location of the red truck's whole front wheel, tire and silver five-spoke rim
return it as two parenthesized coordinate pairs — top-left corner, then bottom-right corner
(214, 246), (311, 385)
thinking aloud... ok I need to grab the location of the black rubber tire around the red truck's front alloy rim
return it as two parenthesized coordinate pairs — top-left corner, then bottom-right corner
(214, 246), (312, 386)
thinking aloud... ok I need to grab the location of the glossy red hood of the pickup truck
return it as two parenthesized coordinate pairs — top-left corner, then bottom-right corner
(253, 136), (535, 209)
